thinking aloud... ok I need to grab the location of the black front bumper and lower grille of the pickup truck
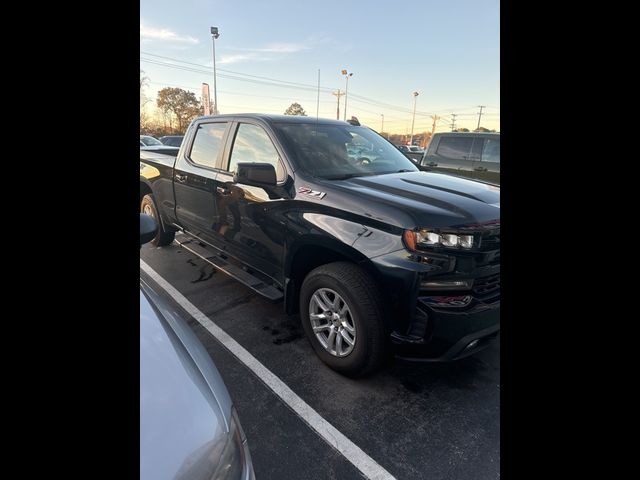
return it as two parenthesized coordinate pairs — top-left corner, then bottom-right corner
(364, 233), (500, 362)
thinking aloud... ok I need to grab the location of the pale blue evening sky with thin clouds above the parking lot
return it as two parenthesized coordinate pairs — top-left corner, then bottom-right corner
(140, 0), (500, 133)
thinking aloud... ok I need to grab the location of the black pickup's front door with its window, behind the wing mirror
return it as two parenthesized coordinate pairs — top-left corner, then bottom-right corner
(214, 121), (287, 281)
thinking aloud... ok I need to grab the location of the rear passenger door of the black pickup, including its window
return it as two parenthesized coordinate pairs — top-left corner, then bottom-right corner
(173, 120), (231, 246)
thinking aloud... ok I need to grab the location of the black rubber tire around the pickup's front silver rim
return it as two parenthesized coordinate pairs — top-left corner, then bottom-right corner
(300, 262), (386, 377)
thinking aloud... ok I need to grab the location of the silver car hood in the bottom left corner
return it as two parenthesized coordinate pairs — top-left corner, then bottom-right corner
(140, 282), (231, 480)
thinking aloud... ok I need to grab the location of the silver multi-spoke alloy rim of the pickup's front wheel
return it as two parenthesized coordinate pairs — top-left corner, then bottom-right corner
(309, 288), (356, 357)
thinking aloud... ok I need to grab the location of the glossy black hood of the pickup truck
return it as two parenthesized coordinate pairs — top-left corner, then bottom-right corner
(323, 172), (500, 228)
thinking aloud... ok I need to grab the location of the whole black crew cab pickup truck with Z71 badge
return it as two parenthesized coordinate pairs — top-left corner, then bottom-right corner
(140, 114), (500, 376)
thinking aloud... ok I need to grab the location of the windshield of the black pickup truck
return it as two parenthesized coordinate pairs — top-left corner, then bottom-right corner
(275, 123), (418, 180)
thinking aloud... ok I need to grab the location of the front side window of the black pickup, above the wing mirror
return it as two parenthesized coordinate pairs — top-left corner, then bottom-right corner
(229, 123), (286, 182)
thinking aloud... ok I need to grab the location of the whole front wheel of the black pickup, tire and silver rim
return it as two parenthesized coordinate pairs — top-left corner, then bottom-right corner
(300, 262), (386, 377)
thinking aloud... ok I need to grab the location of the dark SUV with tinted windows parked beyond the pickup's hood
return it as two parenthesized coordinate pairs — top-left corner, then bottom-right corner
(418, 132), (500, 185)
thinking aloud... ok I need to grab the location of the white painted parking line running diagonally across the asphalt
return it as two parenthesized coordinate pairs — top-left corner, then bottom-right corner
(140, 259), (395, 480)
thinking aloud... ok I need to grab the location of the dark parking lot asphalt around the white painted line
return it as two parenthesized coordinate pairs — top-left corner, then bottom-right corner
(140, 243), (500, 480)
